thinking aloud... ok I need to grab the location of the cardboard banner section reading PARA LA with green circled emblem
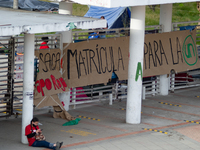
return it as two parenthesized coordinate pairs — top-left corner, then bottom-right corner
(143, 30), (200, 76)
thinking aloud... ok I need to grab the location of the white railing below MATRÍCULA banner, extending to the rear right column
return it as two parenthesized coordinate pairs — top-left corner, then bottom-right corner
(70, 77), (160, 109)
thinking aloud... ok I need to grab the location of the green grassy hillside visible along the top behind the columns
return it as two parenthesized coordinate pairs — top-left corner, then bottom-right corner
(72, 2), (199, 25)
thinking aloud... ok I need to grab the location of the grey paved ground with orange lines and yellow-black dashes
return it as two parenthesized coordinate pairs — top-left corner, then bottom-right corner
(0, 87), (200, 150)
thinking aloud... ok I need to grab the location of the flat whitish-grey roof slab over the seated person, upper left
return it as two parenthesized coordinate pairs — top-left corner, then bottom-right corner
(0, 8), (107, 36)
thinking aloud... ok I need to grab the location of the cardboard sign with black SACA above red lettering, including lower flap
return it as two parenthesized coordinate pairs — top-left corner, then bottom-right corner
(34, 49), (69, 110)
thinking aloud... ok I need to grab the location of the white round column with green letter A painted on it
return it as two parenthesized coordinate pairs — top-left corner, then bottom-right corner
(126, 6), (145, 124)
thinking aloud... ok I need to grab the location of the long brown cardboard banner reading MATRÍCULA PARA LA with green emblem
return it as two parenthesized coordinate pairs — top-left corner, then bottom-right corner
(63, 30), (200, 88)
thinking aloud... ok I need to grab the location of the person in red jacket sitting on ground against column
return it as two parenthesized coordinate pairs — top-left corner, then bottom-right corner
(25, 117), (63, 150)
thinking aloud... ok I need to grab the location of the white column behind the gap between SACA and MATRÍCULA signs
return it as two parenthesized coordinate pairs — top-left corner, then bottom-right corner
(58, 2), (73, 111)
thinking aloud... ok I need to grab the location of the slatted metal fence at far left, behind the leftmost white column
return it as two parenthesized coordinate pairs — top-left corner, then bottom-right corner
(0, 34), (60, 117)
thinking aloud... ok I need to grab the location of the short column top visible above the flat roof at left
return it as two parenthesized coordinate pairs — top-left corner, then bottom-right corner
(58, 1), (73, 15)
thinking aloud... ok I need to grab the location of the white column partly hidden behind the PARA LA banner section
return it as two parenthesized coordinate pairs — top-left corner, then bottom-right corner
(160, 4), (172, 95)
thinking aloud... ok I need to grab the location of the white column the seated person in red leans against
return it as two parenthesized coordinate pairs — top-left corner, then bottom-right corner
(21, 34), (35, 144)
